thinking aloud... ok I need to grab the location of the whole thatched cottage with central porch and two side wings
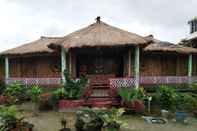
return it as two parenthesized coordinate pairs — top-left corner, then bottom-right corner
(0, 17), (197, 92)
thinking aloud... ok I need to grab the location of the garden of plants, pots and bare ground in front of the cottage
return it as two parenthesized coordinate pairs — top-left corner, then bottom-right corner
(0, 72), (197, 131)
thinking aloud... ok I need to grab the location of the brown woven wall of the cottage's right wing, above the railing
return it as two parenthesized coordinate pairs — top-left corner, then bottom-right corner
(140, 54), (188, 76)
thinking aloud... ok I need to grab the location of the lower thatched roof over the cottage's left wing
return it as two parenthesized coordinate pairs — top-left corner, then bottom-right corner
(0, 36), (61, 55)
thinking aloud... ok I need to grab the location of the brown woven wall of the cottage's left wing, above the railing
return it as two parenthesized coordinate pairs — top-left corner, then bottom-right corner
(9, 56), (60, 78)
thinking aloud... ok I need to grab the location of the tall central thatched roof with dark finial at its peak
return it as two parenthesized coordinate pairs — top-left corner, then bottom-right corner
(50, 17), (147, 49)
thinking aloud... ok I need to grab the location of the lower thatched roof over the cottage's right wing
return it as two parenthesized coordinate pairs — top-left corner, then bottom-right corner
(144, 36), (197, 54)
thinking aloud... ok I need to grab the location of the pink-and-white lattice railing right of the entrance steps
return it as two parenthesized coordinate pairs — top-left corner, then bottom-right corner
(110, 76), (197, 88)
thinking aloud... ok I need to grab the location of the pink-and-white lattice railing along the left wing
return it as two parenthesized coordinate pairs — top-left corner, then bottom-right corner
(5, 78), (61, 86)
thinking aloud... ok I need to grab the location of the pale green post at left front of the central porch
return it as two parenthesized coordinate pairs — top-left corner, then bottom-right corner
(61, 47), (66, 83)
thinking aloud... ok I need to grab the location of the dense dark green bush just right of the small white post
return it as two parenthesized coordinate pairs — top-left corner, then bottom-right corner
(156, 85), (177, 110)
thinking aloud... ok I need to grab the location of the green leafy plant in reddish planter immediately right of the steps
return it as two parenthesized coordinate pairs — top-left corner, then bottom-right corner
(118, 88), (145, 113)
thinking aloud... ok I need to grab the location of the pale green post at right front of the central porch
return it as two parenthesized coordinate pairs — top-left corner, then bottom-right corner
(134, 46), (140, 88)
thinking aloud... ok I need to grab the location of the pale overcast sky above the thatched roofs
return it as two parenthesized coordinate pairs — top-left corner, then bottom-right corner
(0, 0), (197, 51)
